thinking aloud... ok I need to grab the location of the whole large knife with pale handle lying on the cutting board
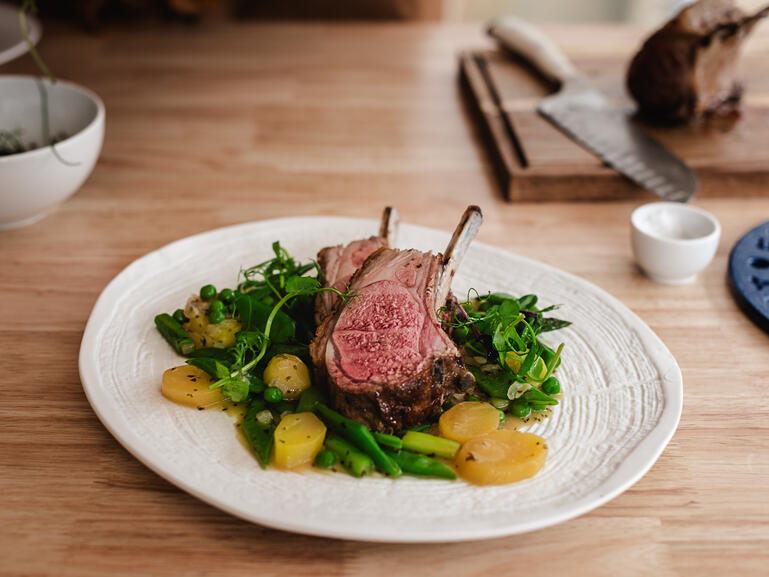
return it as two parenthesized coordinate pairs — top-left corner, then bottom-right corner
(488, 17), (698, 202)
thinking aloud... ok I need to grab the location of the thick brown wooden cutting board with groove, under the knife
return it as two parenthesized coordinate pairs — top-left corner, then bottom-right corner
(460, 51), (769, 201)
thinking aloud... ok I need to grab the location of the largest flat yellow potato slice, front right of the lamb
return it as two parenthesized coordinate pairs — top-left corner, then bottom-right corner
(454, 429), (547, 485)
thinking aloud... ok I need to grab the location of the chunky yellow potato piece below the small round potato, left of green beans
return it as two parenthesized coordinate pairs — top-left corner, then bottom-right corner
(273, 413), (326, 469)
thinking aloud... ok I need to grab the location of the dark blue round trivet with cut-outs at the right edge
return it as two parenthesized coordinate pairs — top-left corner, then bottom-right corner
(729, 222), (769, 333)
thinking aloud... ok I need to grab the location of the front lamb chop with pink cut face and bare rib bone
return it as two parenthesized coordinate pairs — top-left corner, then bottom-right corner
(310, 211), (480, 433)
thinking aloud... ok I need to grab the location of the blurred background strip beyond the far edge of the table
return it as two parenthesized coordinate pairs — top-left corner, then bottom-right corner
(24, 0), (765, 28)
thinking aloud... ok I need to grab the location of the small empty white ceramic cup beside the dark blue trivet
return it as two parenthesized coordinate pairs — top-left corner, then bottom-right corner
(630, 202), (721, 284)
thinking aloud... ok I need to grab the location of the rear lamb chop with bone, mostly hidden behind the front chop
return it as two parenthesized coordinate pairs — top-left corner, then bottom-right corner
(315, 206), (400, 325)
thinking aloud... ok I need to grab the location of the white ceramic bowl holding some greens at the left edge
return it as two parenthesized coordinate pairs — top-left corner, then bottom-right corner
(0, 76), (104, 230)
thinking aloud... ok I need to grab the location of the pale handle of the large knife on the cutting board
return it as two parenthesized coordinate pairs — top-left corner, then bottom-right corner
(487, 16), (579, 85)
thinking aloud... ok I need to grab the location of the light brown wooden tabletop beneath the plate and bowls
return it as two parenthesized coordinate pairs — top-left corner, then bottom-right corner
(0, 22), (769, 577)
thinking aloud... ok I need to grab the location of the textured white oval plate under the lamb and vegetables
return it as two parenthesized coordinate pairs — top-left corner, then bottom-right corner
(80, 218), (682, 542)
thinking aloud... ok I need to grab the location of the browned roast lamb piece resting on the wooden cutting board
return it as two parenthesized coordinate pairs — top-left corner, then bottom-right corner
(627, 0), (769, 123)
